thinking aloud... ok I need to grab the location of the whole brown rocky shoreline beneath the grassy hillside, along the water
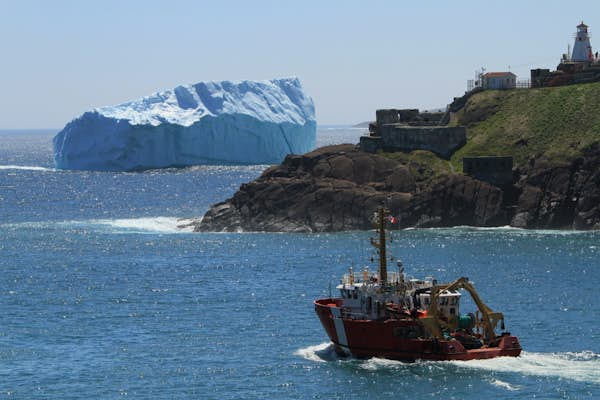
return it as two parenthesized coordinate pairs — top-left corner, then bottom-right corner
(194, 144), (600, 232)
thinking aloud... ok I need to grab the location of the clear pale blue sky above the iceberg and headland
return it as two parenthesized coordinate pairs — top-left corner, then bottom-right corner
(0, 0), (600, 129)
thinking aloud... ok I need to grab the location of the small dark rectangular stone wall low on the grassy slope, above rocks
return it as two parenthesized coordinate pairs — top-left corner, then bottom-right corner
(463, 156), (513, 186)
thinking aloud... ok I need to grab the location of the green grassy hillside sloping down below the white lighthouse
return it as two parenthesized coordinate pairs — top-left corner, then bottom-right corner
(451, 83), (600, 171)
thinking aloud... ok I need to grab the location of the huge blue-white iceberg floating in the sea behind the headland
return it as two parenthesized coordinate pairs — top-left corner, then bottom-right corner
(53, 78), (316, 171)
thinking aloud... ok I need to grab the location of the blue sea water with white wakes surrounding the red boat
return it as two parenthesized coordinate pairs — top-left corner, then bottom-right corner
(0, 127), (600, 399)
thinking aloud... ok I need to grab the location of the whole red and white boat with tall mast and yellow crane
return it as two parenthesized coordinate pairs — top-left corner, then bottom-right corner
(314, 207), (521, 362)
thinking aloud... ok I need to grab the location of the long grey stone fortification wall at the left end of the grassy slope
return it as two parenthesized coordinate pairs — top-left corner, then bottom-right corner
(360, 124), (467, 158)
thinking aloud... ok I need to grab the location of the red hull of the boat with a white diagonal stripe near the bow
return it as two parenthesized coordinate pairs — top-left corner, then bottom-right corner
(315, 299), (521, 361)
